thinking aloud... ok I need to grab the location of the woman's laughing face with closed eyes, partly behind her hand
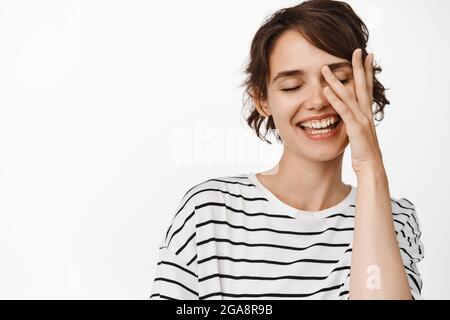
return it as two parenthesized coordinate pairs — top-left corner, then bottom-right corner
(263, 31), (355, 161)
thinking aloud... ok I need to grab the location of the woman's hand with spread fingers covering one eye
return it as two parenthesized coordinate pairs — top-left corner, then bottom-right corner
(322, 49), (383, 175)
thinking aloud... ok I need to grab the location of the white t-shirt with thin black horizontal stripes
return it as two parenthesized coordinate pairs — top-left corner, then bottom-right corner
(150, 173), (424, 300)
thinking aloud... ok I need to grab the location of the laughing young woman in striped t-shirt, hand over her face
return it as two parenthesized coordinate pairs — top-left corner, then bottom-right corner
(150, 0), (424, 299)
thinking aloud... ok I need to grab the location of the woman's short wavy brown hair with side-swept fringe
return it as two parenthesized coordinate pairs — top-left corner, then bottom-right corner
(241, 0), (389, 144)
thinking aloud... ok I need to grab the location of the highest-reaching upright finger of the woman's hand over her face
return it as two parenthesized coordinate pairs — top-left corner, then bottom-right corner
(352, 48), (371, 119)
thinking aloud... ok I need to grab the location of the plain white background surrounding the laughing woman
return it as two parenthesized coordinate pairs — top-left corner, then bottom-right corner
(0, 0), (450, 299)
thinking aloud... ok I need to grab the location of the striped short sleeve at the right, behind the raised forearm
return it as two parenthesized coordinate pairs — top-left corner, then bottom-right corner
(397, 198), (425, 300)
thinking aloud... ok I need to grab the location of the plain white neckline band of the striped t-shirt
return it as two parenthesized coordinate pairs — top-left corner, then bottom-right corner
(247, 172), (356, 219)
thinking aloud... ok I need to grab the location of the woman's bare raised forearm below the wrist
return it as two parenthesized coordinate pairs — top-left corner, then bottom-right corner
(349, 165), (412, 300)
